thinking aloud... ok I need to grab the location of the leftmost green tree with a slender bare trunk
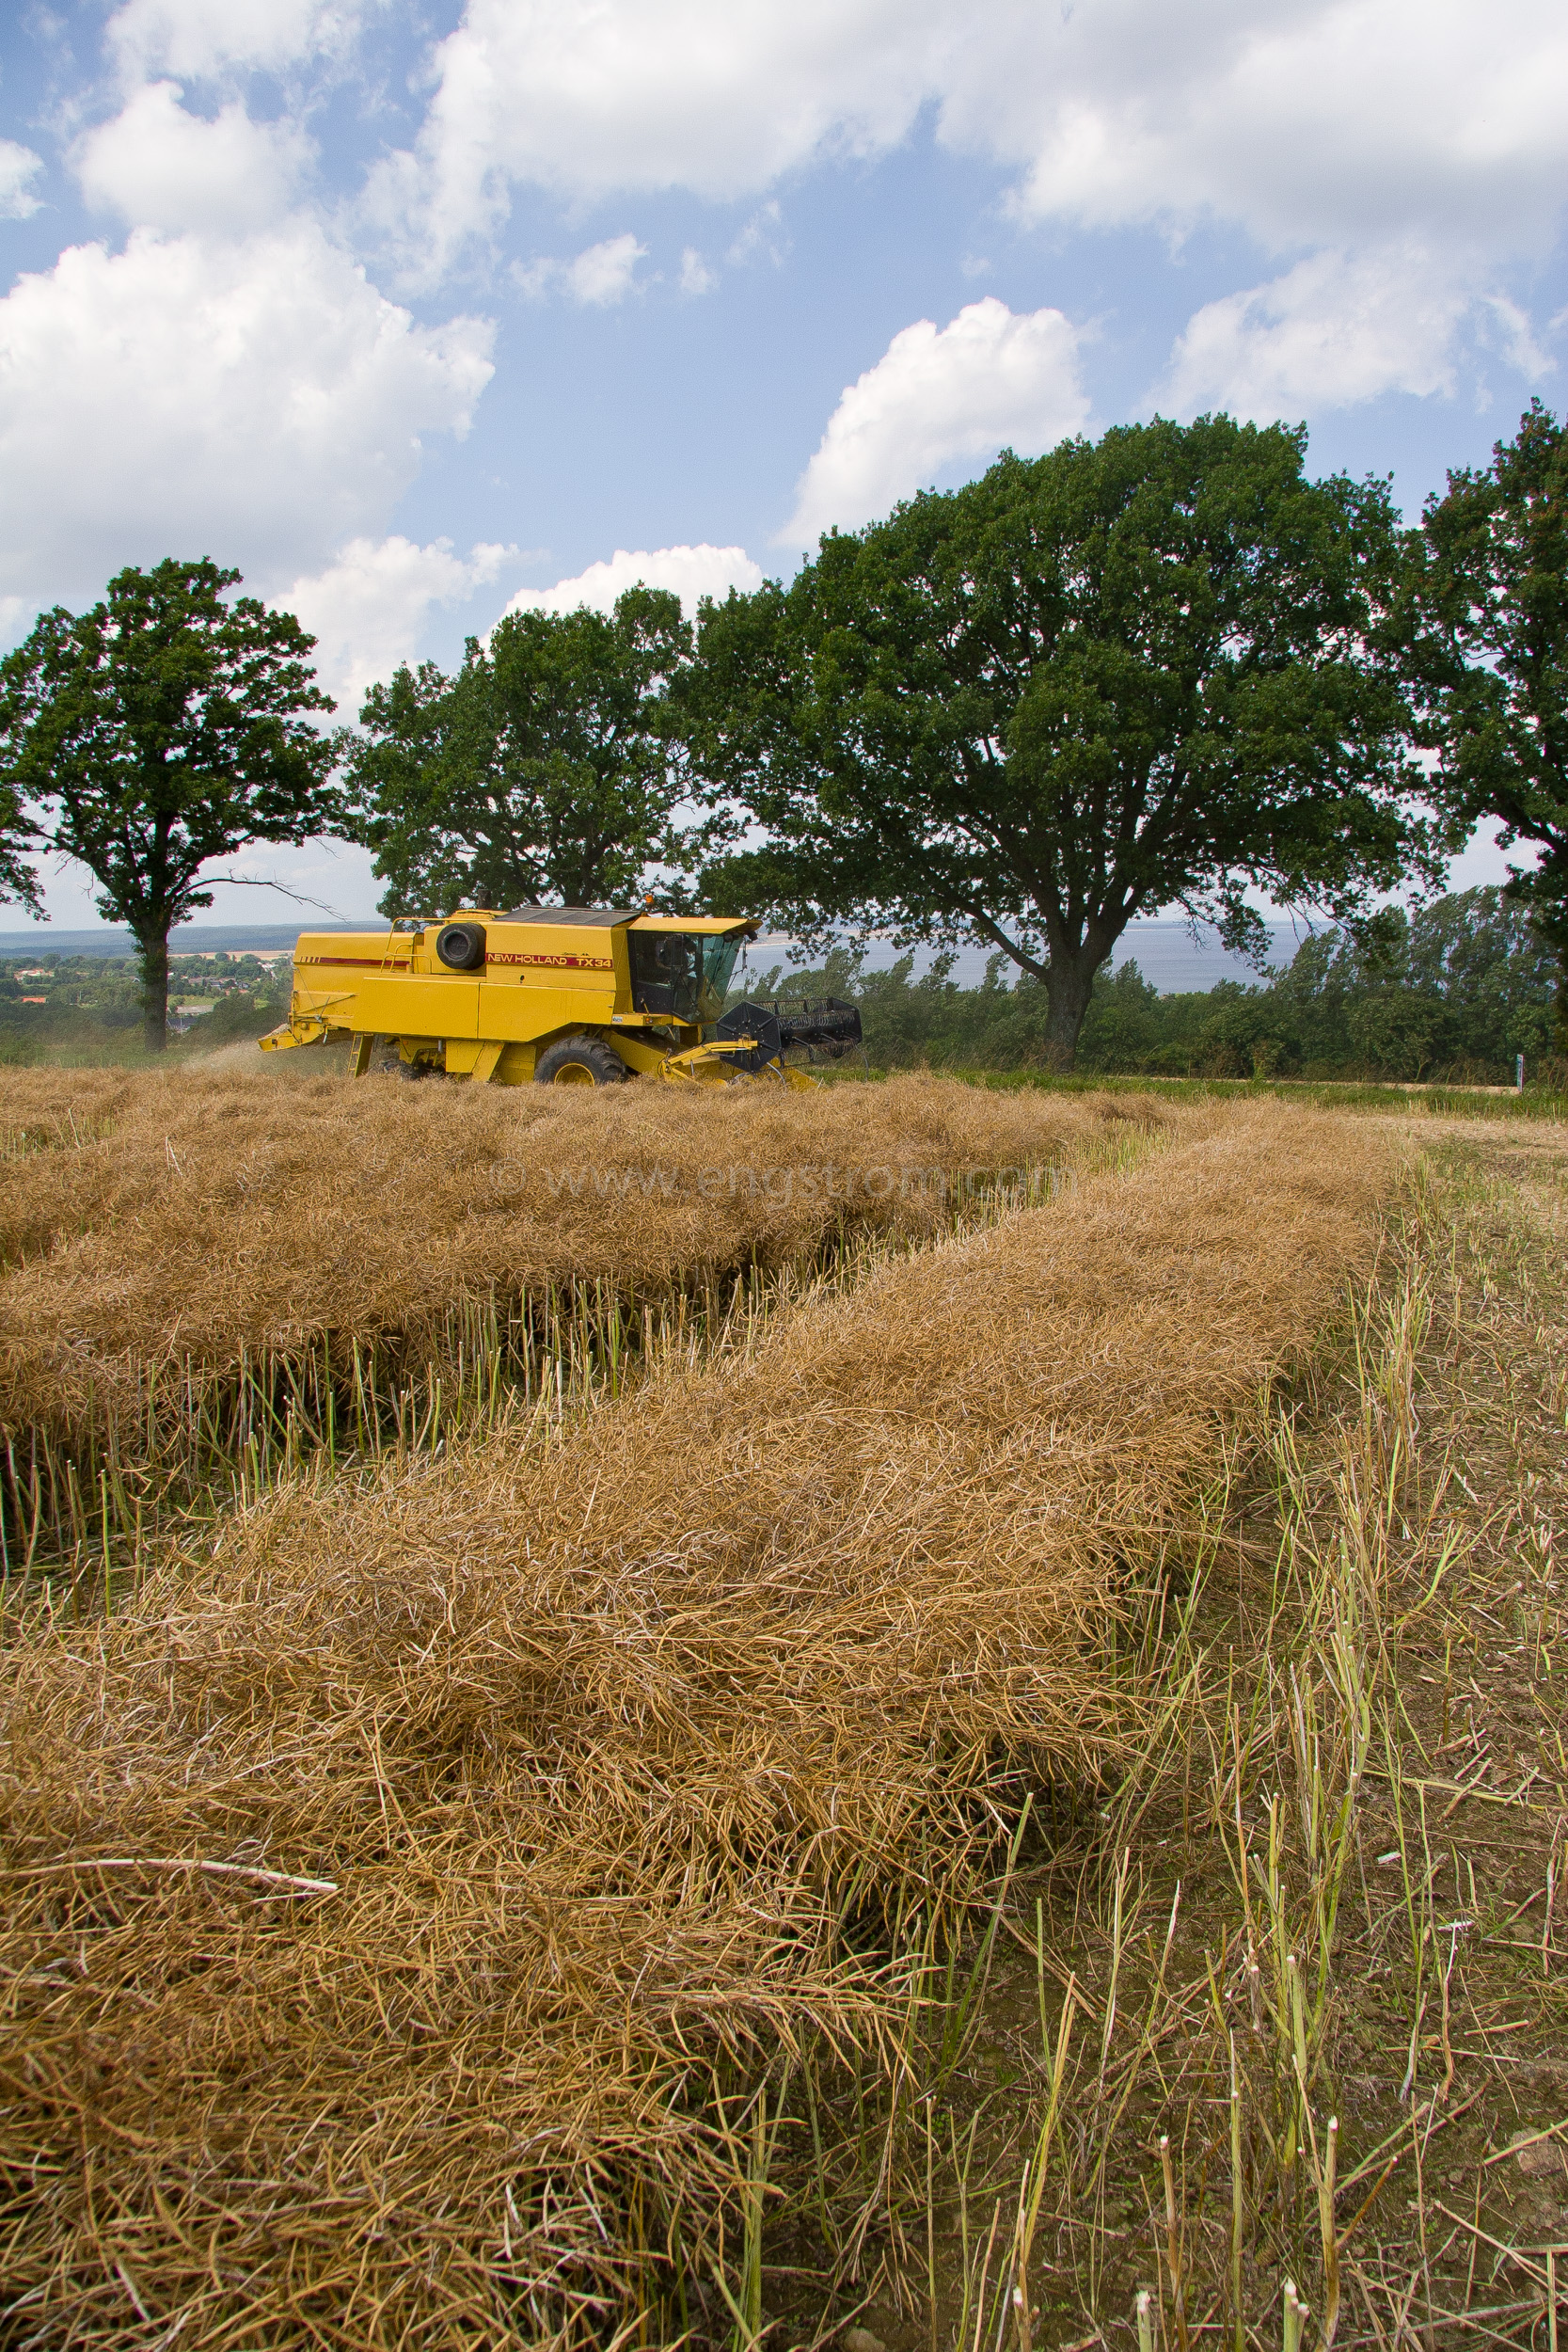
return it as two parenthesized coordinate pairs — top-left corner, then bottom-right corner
(0, 558), (331, 1052)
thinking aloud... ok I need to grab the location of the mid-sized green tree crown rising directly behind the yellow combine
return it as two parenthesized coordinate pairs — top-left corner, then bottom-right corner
(339, 586), (691, 915)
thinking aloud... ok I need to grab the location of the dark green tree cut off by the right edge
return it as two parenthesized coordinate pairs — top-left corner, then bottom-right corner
(1413, 400), (1568, 1052)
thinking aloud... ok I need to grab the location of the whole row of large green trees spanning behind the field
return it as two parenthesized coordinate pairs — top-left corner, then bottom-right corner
(0, 405), (1568, 1068)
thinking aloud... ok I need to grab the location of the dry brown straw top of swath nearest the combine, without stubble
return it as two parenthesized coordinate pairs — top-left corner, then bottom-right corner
(0, 1071), (1132, 1442)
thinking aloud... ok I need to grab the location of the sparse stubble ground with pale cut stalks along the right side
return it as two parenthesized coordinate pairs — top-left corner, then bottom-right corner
(817, 1124), (1568, 2352)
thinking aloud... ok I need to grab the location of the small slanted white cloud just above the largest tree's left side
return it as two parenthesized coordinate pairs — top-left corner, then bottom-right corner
(778, 294), (1088, 548)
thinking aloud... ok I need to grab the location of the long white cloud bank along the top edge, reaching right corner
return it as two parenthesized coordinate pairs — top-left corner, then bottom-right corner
(364, 0), (1568, 285)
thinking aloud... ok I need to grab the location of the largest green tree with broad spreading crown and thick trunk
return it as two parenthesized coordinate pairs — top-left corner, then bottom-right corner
(679, 417), (1427, 1063)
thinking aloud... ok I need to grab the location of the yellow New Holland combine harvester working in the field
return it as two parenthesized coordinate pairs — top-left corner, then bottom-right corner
(261, 906), (861, 1087)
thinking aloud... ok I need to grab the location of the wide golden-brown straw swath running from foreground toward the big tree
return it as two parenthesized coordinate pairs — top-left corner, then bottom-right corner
(0, 1089), (1399, 2347)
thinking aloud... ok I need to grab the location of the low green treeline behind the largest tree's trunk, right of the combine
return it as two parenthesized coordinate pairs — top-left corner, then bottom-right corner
(750, 889), (1557, 1085)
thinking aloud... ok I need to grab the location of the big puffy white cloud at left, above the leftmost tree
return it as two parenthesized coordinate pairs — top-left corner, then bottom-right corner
(0, 221), (491, 600)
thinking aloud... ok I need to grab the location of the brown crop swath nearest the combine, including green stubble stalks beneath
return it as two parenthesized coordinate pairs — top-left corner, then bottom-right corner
(0, 1071), (1151, 1562)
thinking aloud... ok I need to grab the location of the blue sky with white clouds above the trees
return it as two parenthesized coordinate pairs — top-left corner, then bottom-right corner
(0, 0), (1568, 925)
